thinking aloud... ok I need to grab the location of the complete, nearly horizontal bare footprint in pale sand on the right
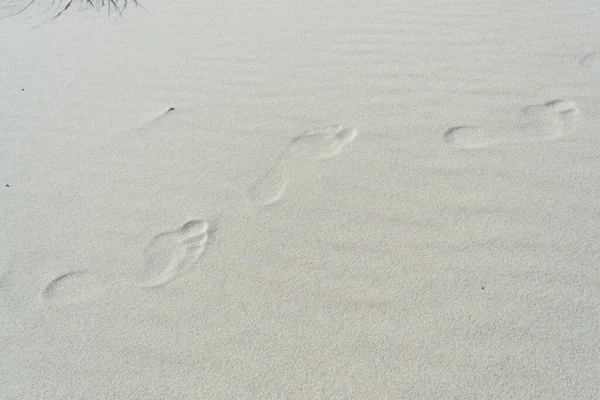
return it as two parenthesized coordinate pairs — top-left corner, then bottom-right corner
(444, 99), (579, 149)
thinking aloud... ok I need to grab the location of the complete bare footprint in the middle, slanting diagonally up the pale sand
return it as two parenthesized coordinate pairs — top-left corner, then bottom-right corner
(248, 124), (358, 206)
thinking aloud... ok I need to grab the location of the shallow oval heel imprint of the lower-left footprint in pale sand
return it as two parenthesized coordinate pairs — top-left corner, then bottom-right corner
(42, 271), (106, 304)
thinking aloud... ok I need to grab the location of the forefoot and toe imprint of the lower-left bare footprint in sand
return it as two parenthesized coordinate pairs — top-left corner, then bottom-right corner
(142, 220), (209, 288)
